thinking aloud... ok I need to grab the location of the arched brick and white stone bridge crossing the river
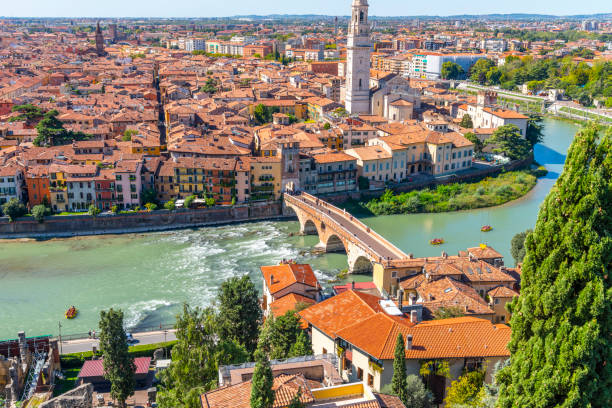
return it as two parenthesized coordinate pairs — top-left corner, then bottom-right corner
(284, 192), (408, 273)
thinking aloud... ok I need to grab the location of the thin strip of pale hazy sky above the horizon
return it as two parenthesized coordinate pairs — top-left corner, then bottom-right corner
(0, 0), (612, 17)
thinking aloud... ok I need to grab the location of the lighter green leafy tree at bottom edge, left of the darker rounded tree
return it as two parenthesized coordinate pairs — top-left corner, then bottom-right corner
(158, 304), (218, 408)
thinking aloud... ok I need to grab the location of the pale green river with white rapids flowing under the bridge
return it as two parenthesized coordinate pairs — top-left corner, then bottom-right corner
(0, 119), (578, 339)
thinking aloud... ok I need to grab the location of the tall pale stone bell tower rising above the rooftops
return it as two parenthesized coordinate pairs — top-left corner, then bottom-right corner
(345, 0), (371, 114)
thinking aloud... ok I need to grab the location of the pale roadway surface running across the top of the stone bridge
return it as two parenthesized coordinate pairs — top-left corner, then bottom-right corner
(293, 195), (403, 259)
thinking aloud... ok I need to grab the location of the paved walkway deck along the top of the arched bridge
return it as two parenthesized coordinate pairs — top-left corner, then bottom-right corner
(292, 194), (407, 259)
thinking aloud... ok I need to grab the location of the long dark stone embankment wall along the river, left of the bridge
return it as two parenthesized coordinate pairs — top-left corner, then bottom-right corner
(0, 202), (286, 239)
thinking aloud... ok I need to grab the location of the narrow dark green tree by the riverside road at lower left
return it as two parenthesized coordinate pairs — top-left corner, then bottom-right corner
(99, 309), (136, 407)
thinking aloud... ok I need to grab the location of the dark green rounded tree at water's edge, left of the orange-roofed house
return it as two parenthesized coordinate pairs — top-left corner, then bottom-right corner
(216, 275), (262, 353)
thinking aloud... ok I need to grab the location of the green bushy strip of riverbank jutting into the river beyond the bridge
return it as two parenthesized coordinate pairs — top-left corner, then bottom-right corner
(349, 170), (545, 216)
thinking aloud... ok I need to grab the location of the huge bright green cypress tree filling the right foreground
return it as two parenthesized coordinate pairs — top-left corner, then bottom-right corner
(498, 125), (612, 408)
